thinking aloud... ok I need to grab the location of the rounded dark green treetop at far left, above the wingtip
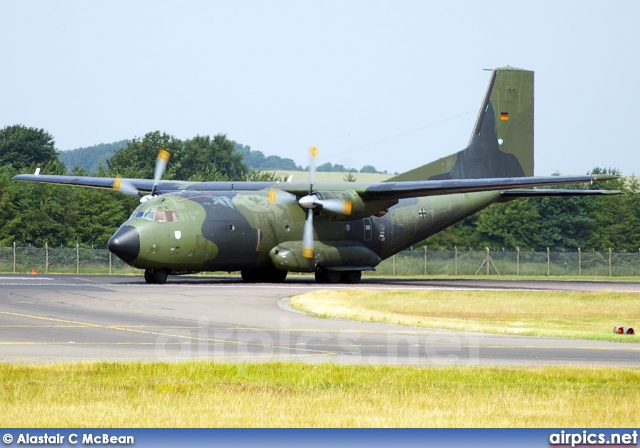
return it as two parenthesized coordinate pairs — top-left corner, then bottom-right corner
(0, 124), (58, 169)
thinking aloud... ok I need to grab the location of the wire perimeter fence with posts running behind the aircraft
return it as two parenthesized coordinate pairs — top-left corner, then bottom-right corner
(0, 244), (640, 277)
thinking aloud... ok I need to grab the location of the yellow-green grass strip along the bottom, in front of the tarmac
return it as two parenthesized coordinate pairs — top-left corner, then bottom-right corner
(0, 362), (640, 427)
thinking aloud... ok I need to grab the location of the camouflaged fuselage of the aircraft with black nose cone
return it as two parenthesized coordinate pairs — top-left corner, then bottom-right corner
(109, 187), (500, 273)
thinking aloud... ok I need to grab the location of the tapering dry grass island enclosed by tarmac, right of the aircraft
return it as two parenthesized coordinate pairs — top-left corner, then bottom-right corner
(291, 289), (640, 342)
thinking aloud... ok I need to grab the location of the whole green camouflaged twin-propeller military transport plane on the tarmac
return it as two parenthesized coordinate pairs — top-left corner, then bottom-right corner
(14, 67), (620, 284)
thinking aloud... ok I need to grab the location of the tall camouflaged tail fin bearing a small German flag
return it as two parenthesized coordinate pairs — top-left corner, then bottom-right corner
(388, 67), (533, 182)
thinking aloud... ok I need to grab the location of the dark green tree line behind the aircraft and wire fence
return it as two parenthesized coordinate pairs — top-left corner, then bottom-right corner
(0, 125), (640, 252)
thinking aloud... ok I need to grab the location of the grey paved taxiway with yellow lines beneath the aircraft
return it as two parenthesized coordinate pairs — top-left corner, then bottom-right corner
(0, 275), (640, 367)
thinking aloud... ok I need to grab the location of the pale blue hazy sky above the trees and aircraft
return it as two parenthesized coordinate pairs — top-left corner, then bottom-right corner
(0, 0), (640, 175)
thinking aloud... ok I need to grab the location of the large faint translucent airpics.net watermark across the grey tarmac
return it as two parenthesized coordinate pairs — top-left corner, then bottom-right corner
(155, 317), (482, 366)
